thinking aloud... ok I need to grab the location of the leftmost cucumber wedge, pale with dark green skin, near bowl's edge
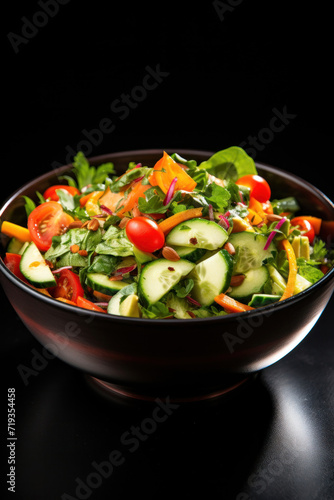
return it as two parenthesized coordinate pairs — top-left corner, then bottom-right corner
(20, 242), (57, 288)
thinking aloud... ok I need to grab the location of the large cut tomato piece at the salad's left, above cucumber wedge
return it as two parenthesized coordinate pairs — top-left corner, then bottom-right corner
(28, 201), (73, 252)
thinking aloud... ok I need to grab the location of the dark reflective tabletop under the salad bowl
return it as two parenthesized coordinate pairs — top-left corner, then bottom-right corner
(1, 284), (334, 500)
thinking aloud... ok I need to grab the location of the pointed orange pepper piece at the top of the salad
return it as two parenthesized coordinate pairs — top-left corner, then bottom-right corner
(149, 151), (197, 194)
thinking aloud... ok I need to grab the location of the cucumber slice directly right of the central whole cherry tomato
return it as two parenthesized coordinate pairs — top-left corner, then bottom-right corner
(166, 218), (228, 250)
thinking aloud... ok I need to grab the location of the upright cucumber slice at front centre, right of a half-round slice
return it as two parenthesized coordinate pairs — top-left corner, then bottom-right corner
(189, 250), (233, 306)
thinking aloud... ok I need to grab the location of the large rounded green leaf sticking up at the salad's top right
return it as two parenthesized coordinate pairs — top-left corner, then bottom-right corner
(199, 146), (257, 181)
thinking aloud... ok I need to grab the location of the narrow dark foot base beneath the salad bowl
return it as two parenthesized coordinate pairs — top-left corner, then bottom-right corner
(88, 374), (256, 403)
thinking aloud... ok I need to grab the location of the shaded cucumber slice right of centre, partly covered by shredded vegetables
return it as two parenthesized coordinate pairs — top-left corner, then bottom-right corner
(228, 231), (276, 274)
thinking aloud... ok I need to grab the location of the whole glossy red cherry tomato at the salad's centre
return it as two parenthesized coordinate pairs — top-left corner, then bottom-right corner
(125, 216), (165, 253)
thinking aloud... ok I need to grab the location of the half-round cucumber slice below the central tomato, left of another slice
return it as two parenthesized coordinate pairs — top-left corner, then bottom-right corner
(138, 259), (195, 306)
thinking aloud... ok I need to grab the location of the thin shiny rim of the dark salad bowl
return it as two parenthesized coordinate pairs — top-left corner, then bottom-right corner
(0, 148), (334, 325)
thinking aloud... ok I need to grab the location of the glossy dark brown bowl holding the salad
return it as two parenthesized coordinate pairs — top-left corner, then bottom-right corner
(0, 150), (334, 400)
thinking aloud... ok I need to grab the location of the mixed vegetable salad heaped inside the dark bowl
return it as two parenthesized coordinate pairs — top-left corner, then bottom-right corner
(1, 147), (334, 319)
